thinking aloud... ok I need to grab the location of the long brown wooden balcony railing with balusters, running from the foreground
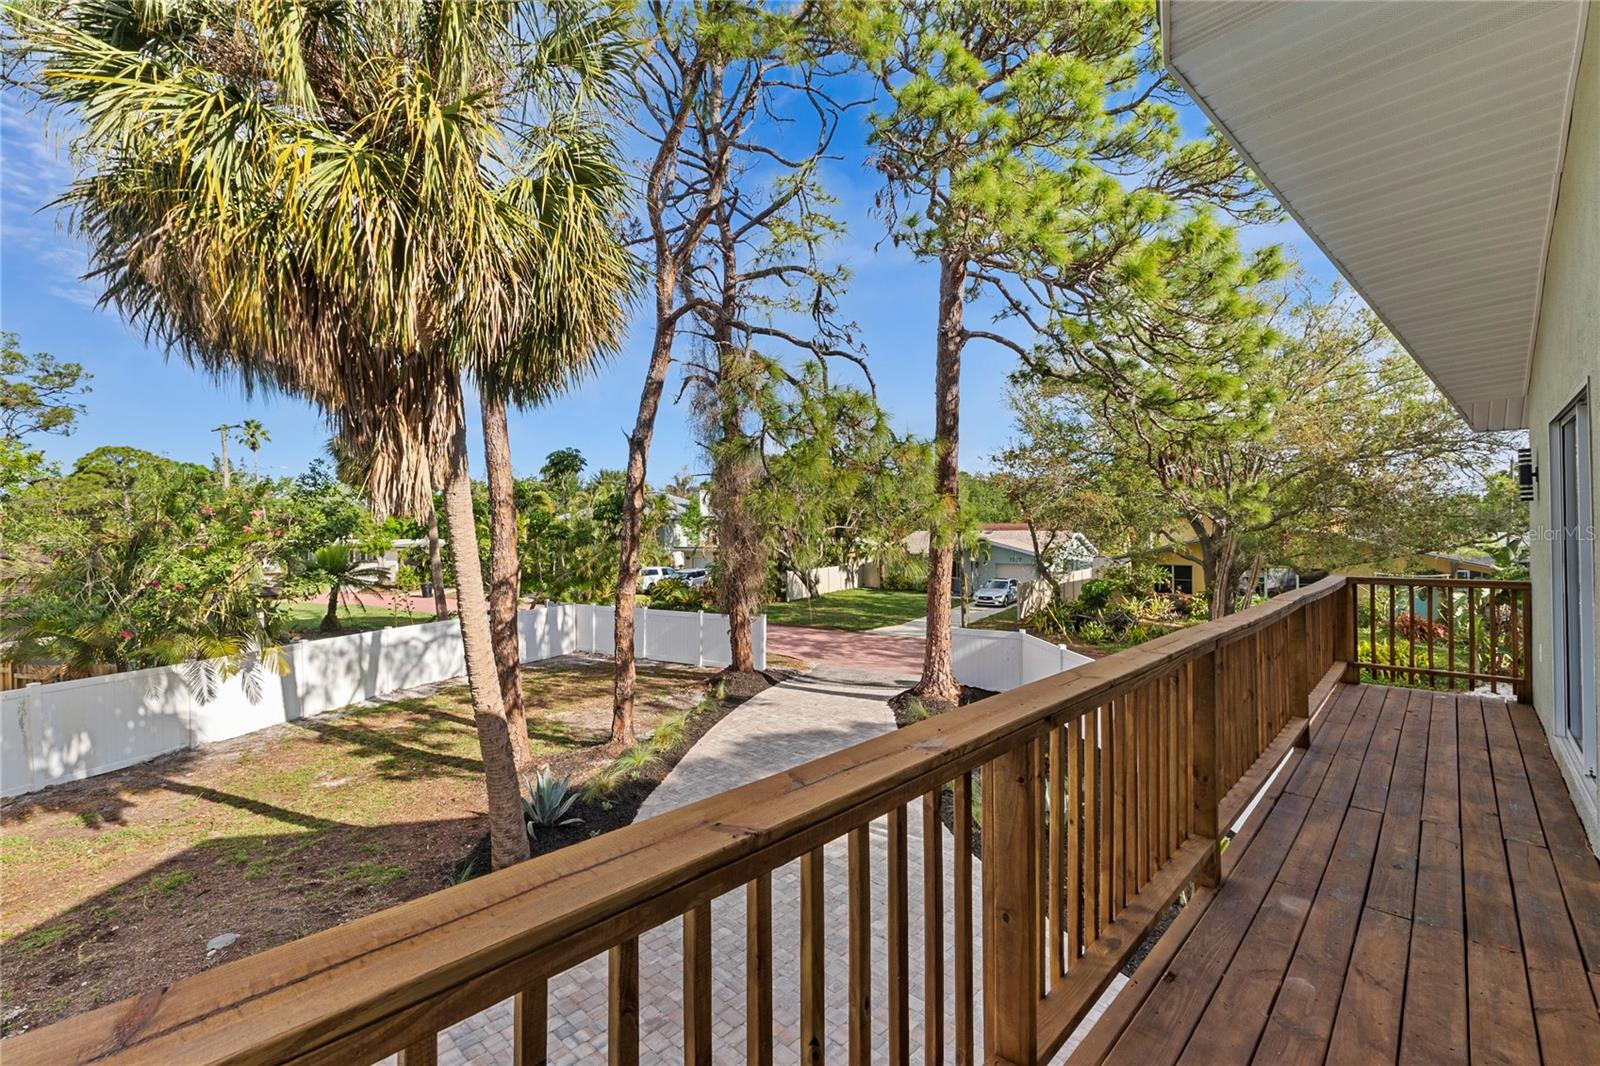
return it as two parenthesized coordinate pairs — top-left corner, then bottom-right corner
(0, 578), (1354, 1066)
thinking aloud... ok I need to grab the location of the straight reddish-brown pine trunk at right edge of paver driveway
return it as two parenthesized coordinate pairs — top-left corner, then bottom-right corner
(912, 256), (966, 704)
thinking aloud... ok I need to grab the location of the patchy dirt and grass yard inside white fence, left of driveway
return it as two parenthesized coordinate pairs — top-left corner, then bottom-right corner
(0, 656), (712, 1032)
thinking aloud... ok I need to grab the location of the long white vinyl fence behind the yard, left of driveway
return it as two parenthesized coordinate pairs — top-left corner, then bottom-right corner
(0, 603), (766, 795)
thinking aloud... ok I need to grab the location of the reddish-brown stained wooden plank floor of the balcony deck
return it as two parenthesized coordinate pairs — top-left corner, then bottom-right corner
(1070, 685), (1600, 1066)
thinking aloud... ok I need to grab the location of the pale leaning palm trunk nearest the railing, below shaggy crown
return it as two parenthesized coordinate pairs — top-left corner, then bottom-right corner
(445, 391), (528, 869)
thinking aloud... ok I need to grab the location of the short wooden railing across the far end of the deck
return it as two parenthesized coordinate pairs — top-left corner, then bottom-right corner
(1350, 578), (1533, 703)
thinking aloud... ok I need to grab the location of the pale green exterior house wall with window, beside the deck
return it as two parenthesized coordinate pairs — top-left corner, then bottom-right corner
(1526, 10), (1600, 850)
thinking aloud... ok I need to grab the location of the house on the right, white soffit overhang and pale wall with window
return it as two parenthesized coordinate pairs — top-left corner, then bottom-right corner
(1162, 0), (1600, 847)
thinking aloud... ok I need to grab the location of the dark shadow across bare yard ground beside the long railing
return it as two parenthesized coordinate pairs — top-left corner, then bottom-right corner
(0, 809), (486, 1034)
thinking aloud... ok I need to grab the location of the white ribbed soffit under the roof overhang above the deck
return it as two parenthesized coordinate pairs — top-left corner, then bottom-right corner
(1162, 0), (1587, 429)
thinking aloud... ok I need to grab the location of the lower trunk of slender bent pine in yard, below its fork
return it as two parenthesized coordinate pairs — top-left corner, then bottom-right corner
(611, 328), (672, 746)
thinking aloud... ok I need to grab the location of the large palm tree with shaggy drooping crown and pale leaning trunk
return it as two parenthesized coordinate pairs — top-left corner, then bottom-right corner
(13, 0), (629, 866)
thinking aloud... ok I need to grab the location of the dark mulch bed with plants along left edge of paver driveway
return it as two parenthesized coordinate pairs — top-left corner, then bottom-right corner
(453, 669), (795, 882)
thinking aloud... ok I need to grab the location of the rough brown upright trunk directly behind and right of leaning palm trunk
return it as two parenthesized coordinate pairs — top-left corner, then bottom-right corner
(478, 386), (533, 773)
